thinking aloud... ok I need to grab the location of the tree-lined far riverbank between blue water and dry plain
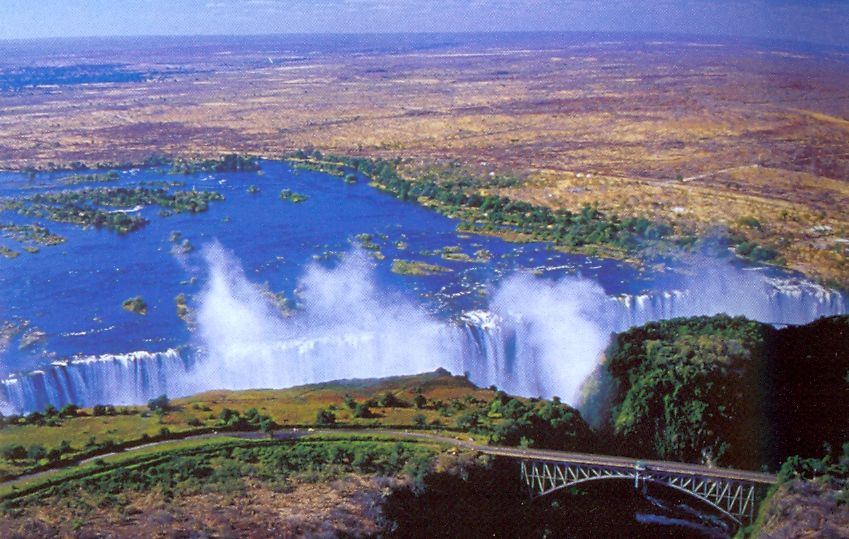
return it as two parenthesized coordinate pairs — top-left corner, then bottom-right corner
(289, 151), (849, 292)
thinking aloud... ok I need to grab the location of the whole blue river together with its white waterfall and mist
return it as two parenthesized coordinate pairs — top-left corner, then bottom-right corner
(0, 161), (846, 412)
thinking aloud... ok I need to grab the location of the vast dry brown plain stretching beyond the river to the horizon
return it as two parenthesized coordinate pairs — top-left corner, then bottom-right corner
(0, 37), (849, 286)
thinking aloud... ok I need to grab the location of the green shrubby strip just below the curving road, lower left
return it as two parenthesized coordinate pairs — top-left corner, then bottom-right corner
(0, 438), (439, 537)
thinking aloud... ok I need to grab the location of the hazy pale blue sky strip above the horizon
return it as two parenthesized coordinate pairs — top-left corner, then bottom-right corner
(0, 0), (849, 46)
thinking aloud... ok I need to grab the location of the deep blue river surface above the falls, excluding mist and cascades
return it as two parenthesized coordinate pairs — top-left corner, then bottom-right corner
(0, 161), (657, 376)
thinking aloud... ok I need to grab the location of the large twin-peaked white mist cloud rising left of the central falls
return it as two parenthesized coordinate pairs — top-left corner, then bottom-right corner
(196, 245), (458, 389)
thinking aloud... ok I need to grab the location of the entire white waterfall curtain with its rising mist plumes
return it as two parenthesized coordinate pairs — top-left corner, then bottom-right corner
(0, 245), (847, 413)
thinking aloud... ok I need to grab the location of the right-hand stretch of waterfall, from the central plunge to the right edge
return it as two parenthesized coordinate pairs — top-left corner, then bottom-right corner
(459, 279), (847, 404)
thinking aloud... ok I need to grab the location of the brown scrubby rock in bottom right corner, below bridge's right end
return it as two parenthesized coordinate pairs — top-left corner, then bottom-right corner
(755, 480), (849, 539)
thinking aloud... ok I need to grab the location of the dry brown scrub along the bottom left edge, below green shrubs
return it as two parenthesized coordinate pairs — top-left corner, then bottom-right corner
(0, 476), (384, 539)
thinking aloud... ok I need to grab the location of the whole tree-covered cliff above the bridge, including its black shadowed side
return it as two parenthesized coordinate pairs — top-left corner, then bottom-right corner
(605, 315), (849, 469)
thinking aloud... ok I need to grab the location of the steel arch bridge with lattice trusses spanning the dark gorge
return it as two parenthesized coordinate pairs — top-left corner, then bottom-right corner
(521, 460), (768, 526)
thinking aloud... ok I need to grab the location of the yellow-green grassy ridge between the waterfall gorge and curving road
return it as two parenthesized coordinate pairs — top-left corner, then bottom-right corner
(0, 371), (494, 475)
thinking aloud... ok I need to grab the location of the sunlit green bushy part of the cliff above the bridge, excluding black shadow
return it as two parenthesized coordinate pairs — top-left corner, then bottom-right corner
(607, 316), (767, 467)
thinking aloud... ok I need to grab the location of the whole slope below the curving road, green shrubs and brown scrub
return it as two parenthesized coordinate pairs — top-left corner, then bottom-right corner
(0, 437), (451, 537)
